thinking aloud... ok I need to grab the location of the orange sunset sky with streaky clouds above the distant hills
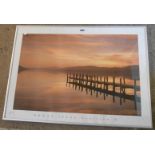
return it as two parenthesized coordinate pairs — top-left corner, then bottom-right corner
(20, 34), (138, 68)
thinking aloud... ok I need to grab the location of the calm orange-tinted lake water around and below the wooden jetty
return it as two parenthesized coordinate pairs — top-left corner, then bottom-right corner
(14, 70), (141, 115)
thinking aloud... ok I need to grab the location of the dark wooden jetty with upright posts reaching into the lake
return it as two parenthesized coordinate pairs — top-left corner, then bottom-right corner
(66, 73), (140, 104)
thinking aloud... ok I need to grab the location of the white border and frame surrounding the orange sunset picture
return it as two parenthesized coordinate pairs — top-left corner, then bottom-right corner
(3, 25), (152, 128)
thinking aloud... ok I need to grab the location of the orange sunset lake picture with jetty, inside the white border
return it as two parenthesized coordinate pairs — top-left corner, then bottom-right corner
(14, 34), (141, 115)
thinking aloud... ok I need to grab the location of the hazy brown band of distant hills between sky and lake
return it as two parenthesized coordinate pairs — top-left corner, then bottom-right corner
(19, 65), (139, 79)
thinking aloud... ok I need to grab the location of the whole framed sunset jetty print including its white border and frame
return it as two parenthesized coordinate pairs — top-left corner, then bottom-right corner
(3, 25), (152, 128)
